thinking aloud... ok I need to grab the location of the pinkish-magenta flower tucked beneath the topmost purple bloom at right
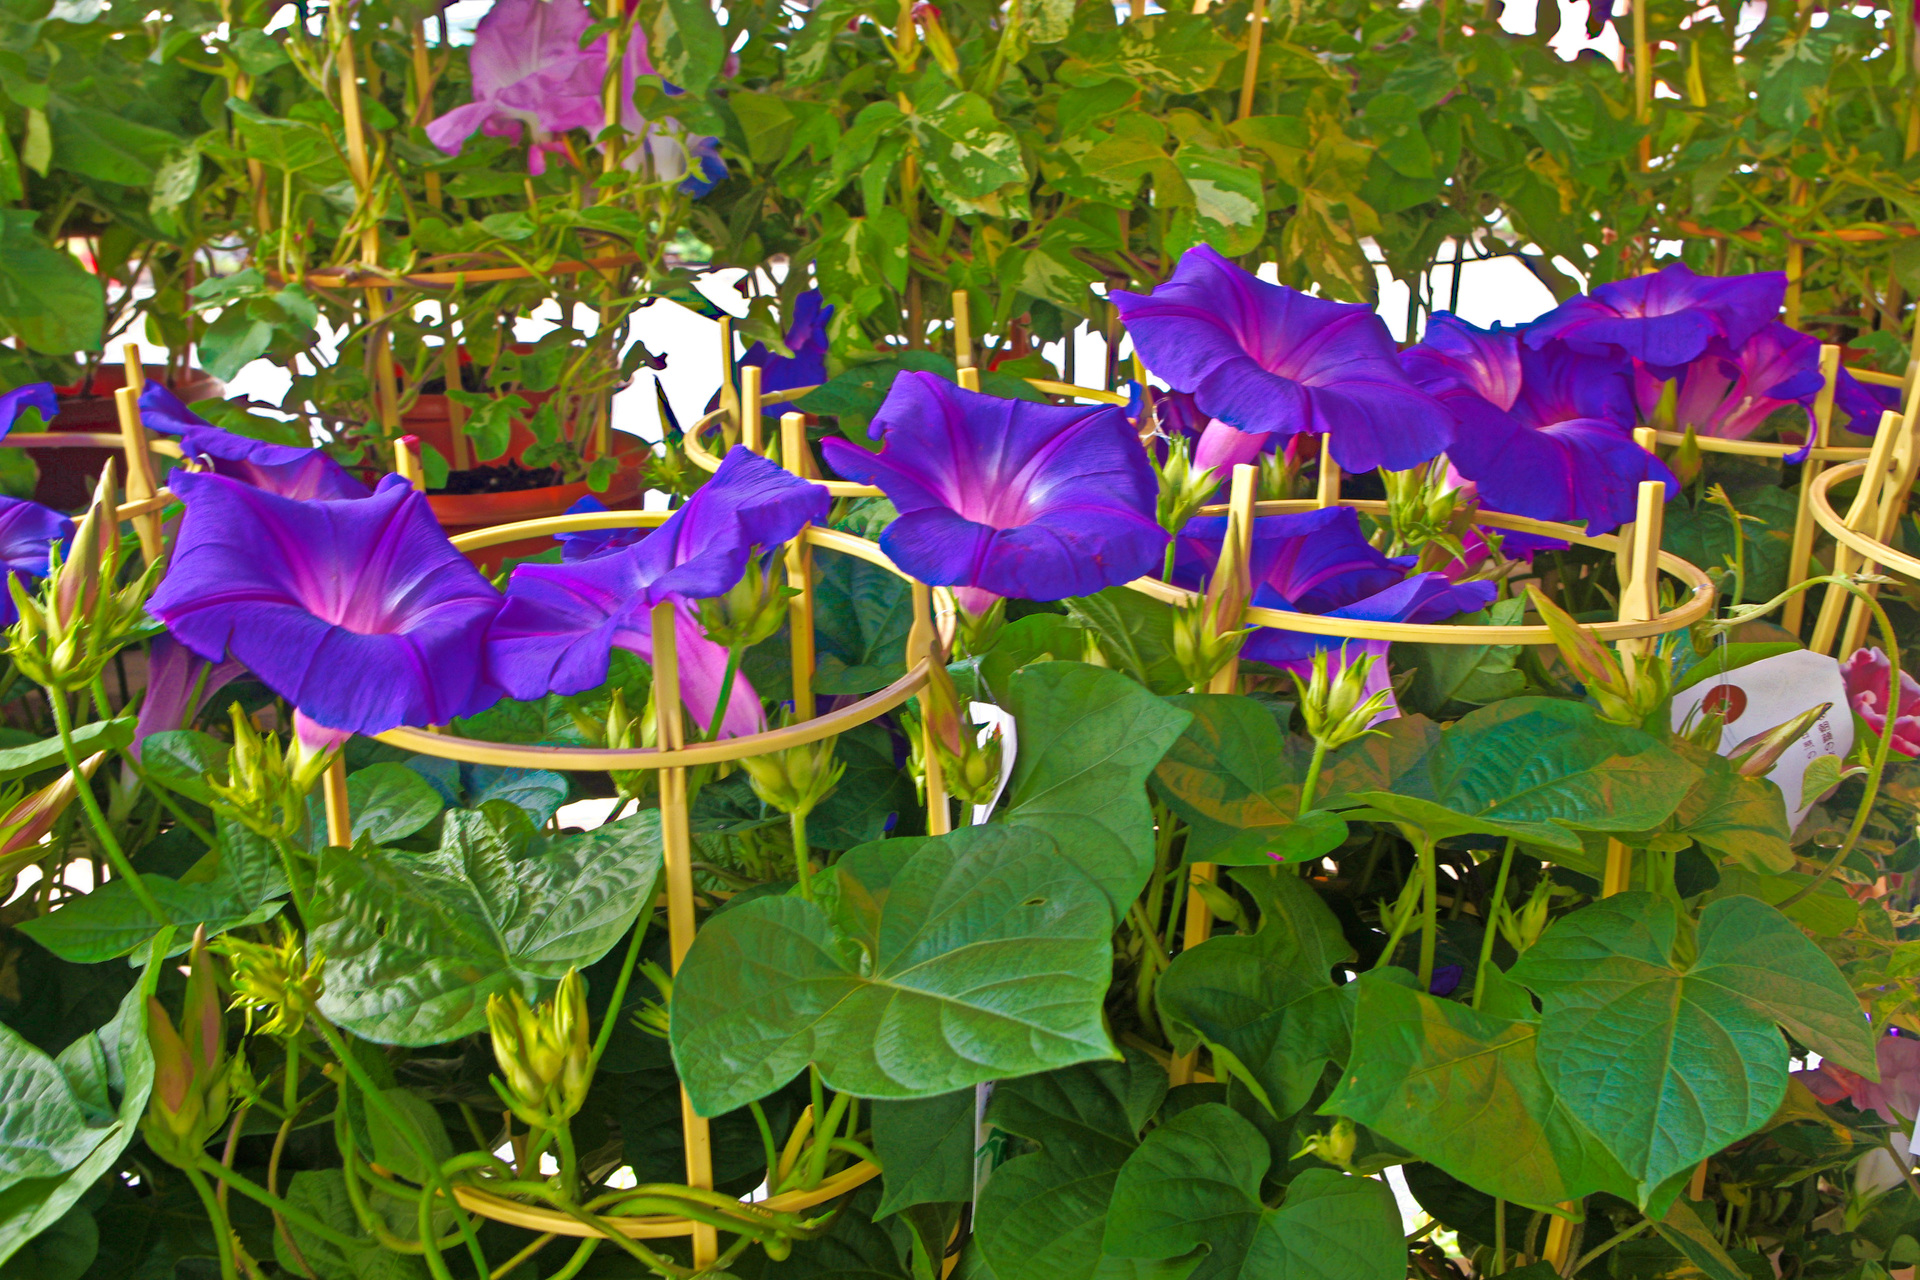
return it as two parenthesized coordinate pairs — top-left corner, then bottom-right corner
(1634, 320), (1826, 439)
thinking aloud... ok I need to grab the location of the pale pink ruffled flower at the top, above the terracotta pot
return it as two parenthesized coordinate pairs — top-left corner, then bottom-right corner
(426, 0), (614, 173)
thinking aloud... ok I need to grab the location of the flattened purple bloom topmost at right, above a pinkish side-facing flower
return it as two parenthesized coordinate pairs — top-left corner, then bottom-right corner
(1526, 263), (1788, 378)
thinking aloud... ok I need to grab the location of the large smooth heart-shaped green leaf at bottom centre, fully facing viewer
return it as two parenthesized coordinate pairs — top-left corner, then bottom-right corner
(670, 825), (1113, 1115)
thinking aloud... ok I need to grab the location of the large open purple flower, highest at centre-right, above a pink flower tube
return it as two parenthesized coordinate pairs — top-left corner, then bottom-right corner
(1114, 244), (1452, 472)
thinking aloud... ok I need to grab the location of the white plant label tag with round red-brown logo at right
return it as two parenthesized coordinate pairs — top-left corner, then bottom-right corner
(1672, 649), (1853, 829)
